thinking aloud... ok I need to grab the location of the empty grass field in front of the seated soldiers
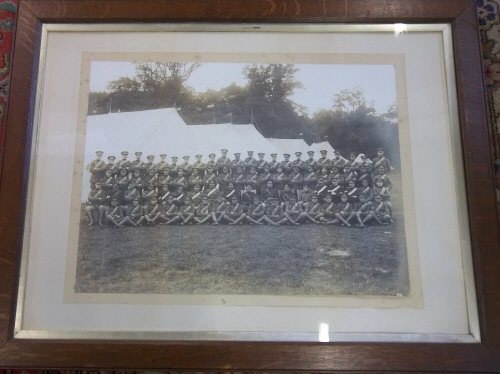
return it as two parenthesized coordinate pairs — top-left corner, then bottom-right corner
(75, 219), (408, 295)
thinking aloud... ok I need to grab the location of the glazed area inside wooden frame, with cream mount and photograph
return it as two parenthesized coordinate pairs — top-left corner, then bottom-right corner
(16, 25), (478, 342)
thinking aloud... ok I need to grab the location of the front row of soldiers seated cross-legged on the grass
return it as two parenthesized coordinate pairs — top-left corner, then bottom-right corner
(86, 187), (393, 227)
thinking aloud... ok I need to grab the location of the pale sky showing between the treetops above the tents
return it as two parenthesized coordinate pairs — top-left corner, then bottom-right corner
(90, 61), (396, 115)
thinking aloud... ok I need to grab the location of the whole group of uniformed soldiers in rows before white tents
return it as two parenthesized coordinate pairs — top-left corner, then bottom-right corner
(85, 148), (393, 227)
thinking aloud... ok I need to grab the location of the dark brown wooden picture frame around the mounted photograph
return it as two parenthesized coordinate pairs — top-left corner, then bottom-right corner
(0, 0), (500, 372)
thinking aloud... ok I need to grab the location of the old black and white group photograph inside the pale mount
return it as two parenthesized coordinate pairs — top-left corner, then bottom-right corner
(74, 60), (410, 298)
